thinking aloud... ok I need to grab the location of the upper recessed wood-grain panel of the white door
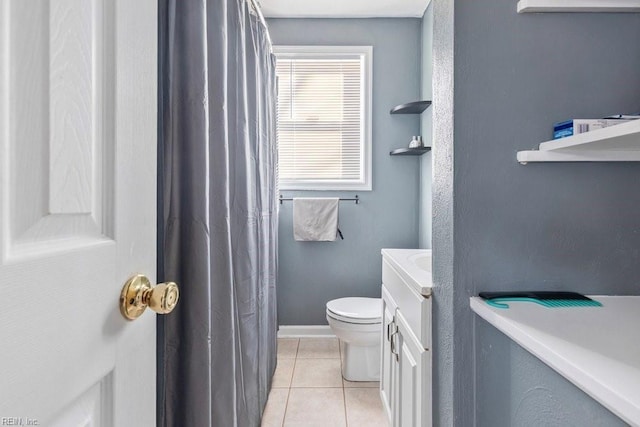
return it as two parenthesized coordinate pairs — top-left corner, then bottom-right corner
(2, 0), (115, 261)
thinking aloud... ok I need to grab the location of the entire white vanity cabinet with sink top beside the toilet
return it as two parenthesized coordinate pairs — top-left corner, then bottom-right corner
(380, 249), (432, 427)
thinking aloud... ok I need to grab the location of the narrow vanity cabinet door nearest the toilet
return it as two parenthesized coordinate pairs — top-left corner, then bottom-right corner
(380, 286), (398, 426)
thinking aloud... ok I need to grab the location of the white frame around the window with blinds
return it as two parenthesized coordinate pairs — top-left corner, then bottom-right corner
(273, 45), (373, 191)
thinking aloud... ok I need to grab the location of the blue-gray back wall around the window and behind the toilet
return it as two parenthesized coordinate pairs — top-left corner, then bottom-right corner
(268, 18), (421, 325)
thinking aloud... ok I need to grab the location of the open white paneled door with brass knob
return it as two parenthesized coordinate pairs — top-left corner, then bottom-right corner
(0, 0), (157, 427)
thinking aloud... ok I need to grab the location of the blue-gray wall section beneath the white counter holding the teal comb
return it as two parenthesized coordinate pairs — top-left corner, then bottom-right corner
(475, 321), (627, 427)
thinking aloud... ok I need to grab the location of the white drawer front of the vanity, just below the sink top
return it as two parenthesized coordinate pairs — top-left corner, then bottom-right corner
(382, 258), (431, 349)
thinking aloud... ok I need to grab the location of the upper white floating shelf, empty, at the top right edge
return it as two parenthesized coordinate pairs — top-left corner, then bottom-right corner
(518, 0), (640, 13)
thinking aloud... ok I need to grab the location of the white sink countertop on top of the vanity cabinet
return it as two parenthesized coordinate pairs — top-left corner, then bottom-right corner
(381, 249), (433, 296)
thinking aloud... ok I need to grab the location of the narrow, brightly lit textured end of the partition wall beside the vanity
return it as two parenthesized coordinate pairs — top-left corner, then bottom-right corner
(431, 0), (456, 427)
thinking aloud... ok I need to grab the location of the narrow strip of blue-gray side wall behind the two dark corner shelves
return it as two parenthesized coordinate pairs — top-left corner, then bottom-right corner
(418, 4), (433, 249)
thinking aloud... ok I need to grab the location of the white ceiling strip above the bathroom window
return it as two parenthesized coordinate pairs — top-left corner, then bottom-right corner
(259, 0), (431, 18)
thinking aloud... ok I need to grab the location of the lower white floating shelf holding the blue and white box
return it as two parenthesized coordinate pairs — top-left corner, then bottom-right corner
(517, 120), (640, 164)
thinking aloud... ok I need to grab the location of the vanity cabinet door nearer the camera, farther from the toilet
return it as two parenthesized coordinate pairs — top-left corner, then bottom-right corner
(395, 310), (431, 427)
